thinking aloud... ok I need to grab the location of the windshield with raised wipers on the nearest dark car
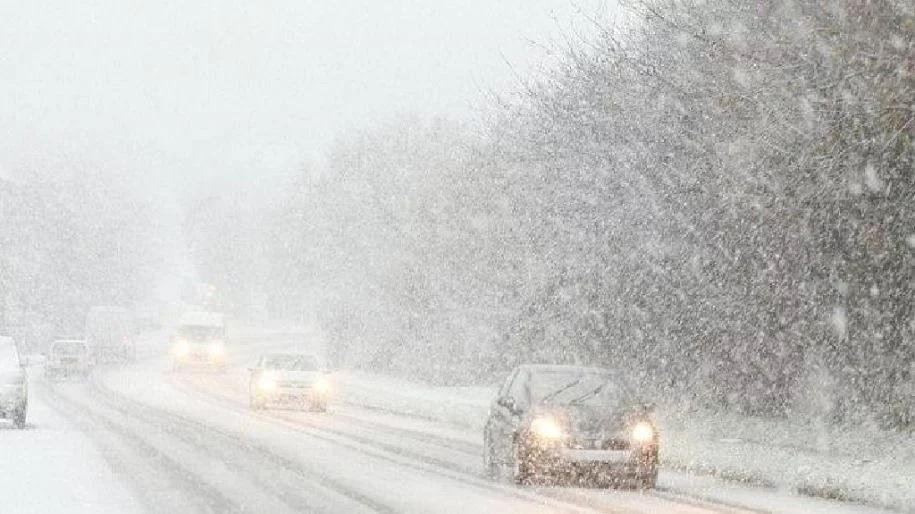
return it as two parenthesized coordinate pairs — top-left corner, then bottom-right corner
(528, 370), (620, 405)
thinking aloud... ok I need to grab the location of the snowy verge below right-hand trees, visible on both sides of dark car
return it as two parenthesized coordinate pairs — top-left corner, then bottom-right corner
(335, 372), (915, 512)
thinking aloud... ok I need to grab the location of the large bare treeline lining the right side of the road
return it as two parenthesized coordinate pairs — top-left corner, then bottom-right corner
(188, 0), (915, 426)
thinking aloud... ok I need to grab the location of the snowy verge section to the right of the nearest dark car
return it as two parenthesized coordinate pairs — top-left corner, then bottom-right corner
(662, 413), (915, 512)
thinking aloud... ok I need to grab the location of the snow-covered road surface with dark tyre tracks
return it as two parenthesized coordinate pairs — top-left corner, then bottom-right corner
(12, 337), (896, 514)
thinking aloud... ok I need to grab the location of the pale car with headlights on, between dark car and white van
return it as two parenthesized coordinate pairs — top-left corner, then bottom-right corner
(248, 353), (330, 412)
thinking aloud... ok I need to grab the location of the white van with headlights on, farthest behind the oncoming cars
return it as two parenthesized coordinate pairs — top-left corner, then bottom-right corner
(171, 311), (226, 371)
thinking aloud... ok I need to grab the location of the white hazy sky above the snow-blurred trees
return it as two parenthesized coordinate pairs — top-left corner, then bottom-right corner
(0, 0), (611, 190)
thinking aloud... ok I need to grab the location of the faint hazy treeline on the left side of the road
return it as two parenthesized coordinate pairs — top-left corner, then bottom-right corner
(0, 168), (161, 351)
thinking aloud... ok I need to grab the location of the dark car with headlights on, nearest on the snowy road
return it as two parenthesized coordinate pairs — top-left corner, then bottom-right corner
(483, 365), (660, 488)
